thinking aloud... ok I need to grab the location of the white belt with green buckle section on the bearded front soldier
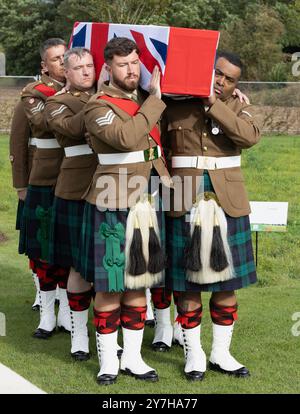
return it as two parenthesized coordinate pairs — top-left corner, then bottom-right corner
(98, 146), (161, 165)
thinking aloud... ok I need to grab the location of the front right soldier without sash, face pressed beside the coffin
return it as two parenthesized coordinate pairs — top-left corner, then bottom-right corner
(165, 53), (260, 380)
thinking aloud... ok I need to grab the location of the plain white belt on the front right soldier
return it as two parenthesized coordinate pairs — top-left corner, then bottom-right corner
(172, 155), (241, 170)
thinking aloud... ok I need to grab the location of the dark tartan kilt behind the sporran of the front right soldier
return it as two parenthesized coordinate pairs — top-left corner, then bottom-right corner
(166, 173), (257, 292)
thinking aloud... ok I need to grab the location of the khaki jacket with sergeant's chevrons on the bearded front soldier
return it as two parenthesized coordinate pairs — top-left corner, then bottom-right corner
(85, 84), (170, 208)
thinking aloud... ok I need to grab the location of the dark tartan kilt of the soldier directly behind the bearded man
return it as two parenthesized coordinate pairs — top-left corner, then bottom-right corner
(49, 197), (85, 269)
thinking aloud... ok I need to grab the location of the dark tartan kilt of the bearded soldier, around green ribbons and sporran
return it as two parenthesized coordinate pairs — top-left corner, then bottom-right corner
(78, 203), (165, 292)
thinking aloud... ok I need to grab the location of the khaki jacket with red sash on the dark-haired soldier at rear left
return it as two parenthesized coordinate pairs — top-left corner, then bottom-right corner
(21, 75), (64, 186)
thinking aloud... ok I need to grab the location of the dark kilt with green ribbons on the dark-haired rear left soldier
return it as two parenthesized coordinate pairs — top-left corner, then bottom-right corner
(19, 185), (54, 261)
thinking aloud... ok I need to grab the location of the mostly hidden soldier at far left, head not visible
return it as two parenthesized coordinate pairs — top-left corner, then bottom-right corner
(9, 101), (40, 310)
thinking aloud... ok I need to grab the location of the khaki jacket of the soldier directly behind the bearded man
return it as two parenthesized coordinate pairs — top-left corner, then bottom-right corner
(45, 89), (98, 200)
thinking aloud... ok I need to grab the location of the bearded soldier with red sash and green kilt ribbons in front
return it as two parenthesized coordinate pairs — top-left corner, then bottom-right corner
(79, 38), (170, 385)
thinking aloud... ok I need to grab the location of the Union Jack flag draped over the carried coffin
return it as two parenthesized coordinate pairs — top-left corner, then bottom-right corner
(69, 22), (219, 97)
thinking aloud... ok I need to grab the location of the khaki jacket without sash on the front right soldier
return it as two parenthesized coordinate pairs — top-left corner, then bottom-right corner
(164, 97), (260, 217)
